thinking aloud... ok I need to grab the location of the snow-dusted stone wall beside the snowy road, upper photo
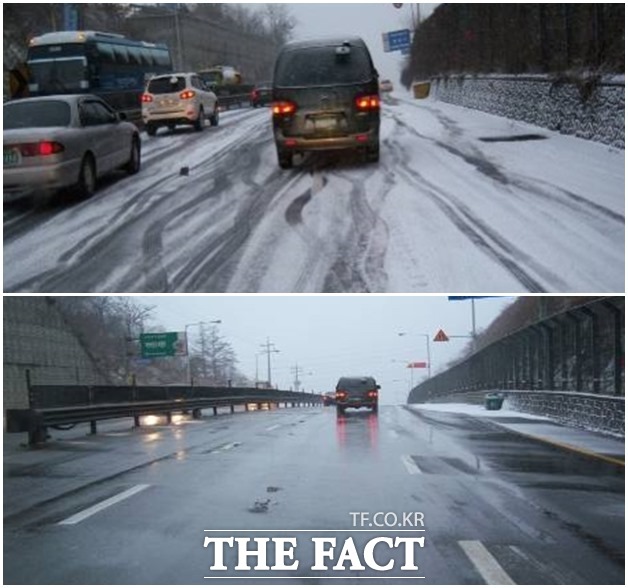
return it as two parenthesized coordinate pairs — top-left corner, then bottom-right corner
(432, 75), (625, 149)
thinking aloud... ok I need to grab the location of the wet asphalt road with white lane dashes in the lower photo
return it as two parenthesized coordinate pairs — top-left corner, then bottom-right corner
(4, 407), (624, 584)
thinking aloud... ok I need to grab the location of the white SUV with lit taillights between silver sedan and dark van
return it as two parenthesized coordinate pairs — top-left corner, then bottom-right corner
(142, 73), (219, 136)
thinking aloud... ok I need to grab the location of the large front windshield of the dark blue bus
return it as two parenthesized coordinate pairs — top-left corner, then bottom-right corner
(28, 57), (87, 94)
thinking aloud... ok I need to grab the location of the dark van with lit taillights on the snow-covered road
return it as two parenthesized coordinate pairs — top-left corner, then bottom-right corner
(272, 37), (380, 169)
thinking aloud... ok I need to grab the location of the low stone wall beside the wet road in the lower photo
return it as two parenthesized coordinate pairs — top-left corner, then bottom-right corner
(505, 390), (625, 436)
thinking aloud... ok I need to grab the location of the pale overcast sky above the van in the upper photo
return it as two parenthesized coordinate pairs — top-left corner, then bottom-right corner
(282, 2), (438, 85)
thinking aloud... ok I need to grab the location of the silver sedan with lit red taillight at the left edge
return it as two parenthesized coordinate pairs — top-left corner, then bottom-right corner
(3, 94), (141, 202)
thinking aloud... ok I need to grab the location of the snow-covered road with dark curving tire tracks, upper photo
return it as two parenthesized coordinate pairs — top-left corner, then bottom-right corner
(4, 96), (624, 293)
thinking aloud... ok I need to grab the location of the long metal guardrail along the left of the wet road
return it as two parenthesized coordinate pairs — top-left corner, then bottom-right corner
(6, 385), (322, 446)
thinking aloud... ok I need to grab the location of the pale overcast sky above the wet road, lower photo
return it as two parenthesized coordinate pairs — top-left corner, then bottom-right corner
(135, 295), (514, 404)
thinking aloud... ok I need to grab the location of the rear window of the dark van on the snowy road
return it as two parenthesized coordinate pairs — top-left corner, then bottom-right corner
(275, 46), (373, 88)
